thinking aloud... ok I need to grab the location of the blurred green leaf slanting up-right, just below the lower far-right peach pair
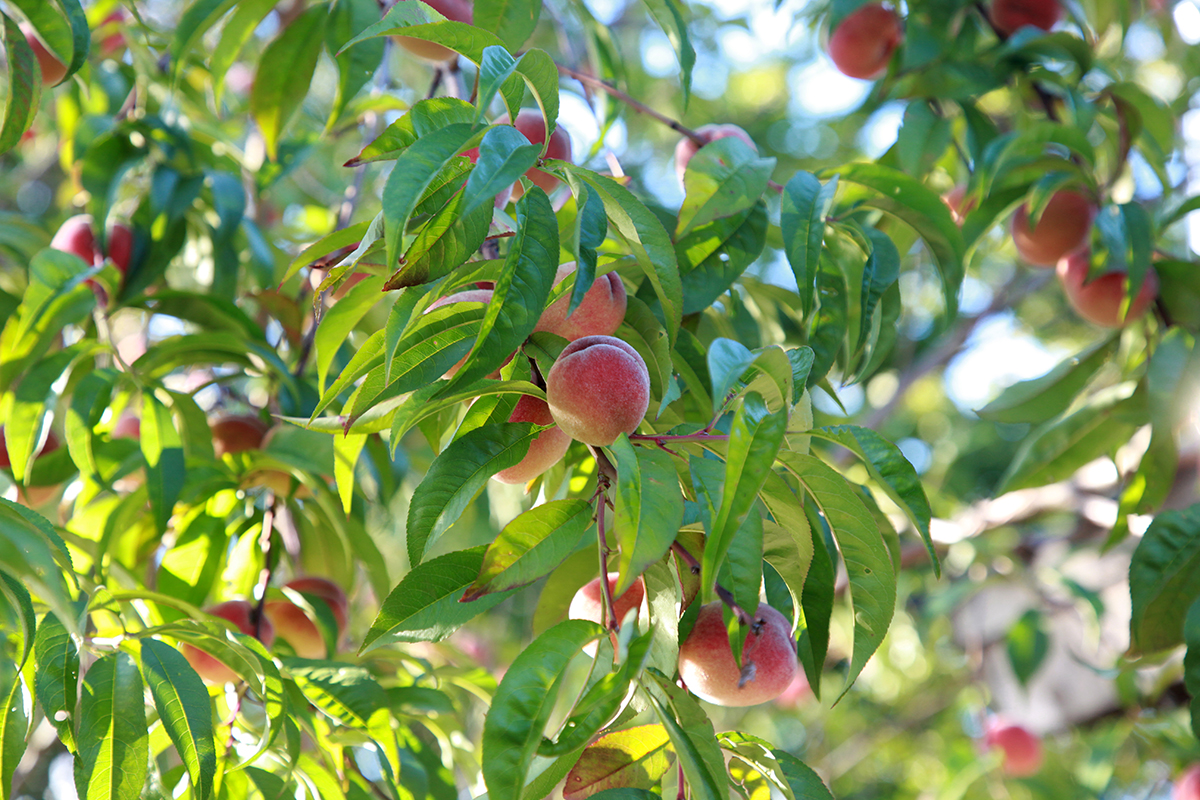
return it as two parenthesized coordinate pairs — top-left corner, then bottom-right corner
(976, 336), (1121, 423)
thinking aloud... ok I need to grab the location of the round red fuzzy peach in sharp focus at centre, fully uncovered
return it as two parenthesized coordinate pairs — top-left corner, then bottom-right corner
(546, 336), (650, 445)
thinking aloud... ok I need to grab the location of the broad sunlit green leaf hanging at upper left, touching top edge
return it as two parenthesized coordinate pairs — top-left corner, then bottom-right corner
(250, 6), (329, 161)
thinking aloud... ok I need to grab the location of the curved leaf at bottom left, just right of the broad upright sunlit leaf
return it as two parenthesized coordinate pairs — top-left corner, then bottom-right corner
(142, 639), (217, 800)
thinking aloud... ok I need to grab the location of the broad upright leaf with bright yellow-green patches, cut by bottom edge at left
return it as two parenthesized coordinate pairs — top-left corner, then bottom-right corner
(74, 652), (150, 800)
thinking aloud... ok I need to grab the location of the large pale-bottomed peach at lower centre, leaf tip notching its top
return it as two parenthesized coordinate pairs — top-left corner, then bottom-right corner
(679, 602), (799, 705)
